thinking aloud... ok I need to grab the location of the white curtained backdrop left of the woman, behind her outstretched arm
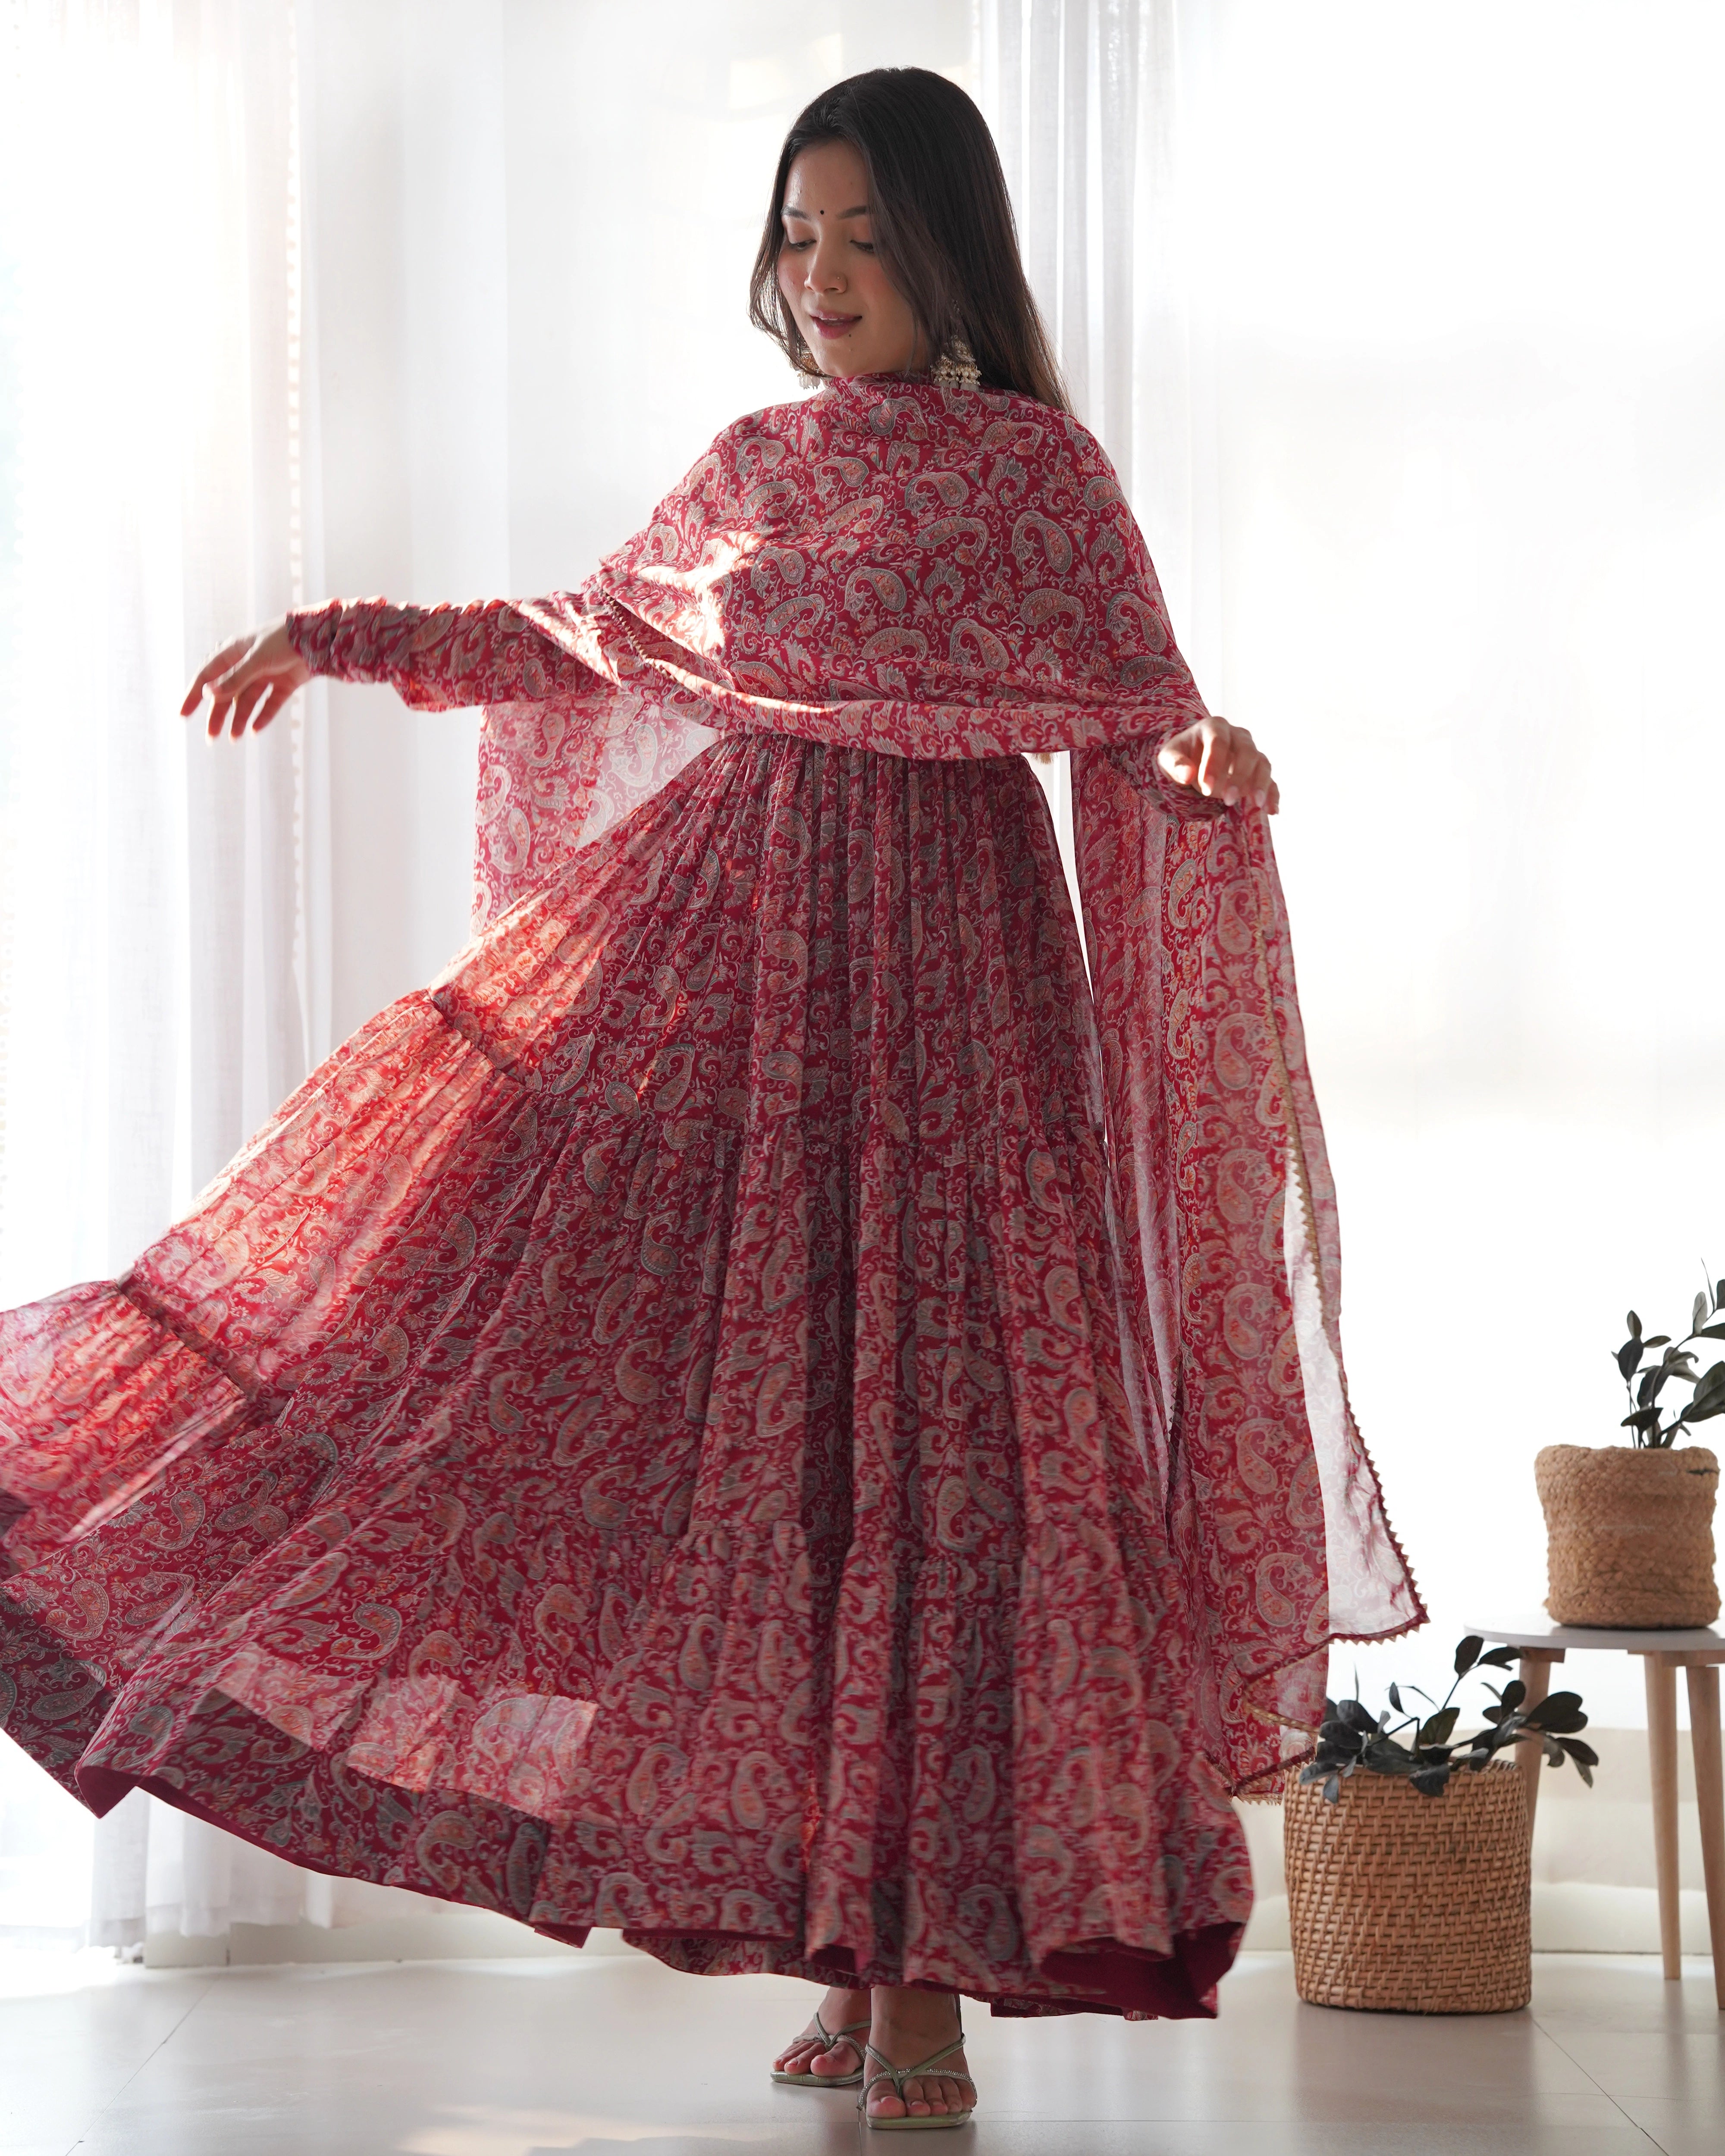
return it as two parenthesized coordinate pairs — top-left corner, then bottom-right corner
(0, 0), (970, 1951)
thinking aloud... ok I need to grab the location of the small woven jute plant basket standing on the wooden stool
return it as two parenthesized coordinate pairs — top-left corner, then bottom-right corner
(1533, 1445), (1719, 1630)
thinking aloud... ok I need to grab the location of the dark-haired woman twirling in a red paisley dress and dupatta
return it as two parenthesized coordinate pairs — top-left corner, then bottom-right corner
(0, 69), (1421, 2128)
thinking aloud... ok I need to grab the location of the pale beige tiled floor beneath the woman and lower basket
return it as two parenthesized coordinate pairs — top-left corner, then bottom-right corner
(0, 1953), (1725, 2156)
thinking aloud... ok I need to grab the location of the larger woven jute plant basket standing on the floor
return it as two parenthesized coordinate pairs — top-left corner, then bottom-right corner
(1283, 1766), (1533, 2014)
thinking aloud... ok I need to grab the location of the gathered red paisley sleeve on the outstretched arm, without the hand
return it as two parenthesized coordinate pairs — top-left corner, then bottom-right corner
(287, 599), (602, 711)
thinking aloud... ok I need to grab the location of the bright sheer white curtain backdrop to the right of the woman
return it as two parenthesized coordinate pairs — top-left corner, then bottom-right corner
(979, 0), (1725, 1727)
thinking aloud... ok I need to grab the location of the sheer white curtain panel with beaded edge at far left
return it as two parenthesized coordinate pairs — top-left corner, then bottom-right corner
(0, 0), (330, 1943)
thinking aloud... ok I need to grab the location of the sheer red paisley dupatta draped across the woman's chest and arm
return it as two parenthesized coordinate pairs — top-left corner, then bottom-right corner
(477, 379), (1425, 1789)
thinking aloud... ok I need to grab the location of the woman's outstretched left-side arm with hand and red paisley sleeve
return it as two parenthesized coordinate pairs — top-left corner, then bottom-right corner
(181, 599), (599, 740)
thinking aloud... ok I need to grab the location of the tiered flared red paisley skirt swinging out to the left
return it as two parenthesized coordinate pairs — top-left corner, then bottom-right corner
(0, 737), (1248, 2014)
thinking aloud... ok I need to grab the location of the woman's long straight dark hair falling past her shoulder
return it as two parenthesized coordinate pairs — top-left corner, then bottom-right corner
(748, 67), (1072, 412)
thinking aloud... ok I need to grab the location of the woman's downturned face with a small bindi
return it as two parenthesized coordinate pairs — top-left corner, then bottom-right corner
(778, 142), (923, 375)
